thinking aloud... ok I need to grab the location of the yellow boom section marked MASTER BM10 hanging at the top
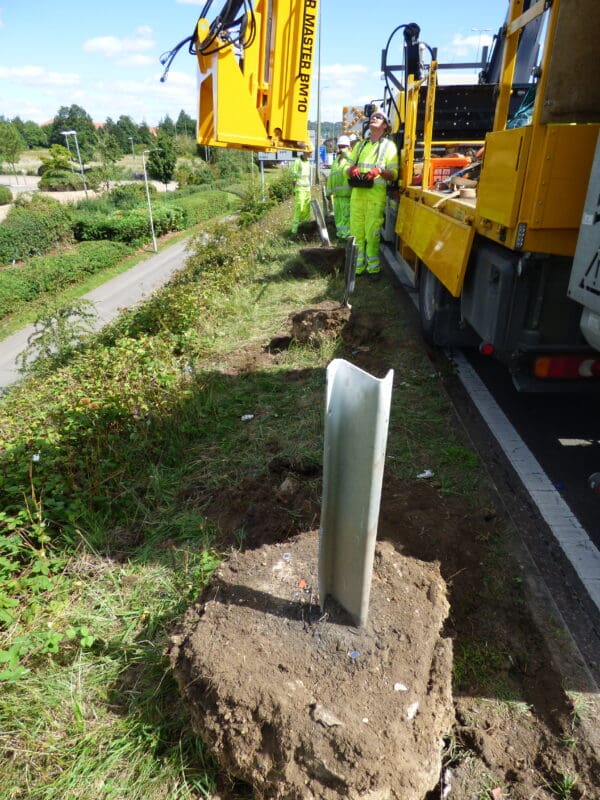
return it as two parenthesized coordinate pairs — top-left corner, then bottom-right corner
(163, 0), (319, 152)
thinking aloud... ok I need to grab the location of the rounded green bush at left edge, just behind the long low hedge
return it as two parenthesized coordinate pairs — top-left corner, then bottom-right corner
(0, 195), (73, 264)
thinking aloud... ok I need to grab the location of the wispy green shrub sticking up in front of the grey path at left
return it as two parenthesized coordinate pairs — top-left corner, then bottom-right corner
(17, 300), (96, 375)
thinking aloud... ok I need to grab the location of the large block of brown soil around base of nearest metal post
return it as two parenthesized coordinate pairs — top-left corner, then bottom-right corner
(170, 532), (454, 800)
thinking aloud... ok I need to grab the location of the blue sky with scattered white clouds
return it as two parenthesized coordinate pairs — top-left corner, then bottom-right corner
(0, 0), (508, 125)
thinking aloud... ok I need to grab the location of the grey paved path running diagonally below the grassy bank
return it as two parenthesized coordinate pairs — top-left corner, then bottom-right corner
(0, 238), (189, 391)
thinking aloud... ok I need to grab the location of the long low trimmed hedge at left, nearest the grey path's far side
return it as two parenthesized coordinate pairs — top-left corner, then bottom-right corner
(0, 242), (131, 318)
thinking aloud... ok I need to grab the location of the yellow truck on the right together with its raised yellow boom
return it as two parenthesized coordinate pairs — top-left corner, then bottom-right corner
(170, 0), (600, 391)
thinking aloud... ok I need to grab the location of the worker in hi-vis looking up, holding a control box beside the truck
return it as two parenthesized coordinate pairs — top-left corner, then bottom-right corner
(345, 111), (398, 277)
